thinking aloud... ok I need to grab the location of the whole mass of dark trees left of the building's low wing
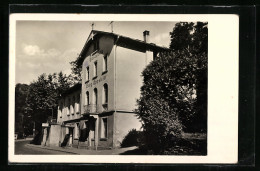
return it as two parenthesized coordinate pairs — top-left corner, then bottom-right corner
(15, 72), (74, 135)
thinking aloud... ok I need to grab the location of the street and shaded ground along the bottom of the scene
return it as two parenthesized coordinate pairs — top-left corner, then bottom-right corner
(15, 133), (207, 155)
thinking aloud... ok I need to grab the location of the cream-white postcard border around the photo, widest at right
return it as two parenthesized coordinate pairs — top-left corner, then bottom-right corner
(8, 14), (239, 164)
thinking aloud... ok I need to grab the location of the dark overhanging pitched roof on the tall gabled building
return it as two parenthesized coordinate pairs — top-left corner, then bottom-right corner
(80, 30), (170, 56)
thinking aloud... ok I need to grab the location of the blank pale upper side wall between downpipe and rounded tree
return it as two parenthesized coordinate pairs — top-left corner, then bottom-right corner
(116, 47), (146, 111)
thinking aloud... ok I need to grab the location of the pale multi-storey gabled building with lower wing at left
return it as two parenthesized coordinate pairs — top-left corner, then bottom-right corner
(41, 30), (169, 148)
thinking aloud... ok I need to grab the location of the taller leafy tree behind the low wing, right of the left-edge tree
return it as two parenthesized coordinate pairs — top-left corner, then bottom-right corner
(26, 72), (73, 131)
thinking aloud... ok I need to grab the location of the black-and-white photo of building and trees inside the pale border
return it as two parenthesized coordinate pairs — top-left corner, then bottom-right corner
(9, 15), (237, 163)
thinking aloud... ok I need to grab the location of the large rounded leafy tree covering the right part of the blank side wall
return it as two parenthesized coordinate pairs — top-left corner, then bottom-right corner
(137, 51), (204, 150)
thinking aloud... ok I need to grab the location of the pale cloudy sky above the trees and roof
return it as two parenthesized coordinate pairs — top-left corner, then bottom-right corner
(15, 21), (176, 84)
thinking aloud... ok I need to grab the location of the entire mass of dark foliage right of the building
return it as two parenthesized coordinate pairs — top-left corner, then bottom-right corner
(137, 22), (207, 152)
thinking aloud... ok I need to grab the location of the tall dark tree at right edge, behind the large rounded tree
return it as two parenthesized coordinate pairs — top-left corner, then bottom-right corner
(170, 22), (208, 132)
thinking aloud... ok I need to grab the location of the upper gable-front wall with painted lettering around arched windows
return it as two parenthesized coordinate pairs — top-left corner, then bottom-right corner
(81, 36), (114, 114)
